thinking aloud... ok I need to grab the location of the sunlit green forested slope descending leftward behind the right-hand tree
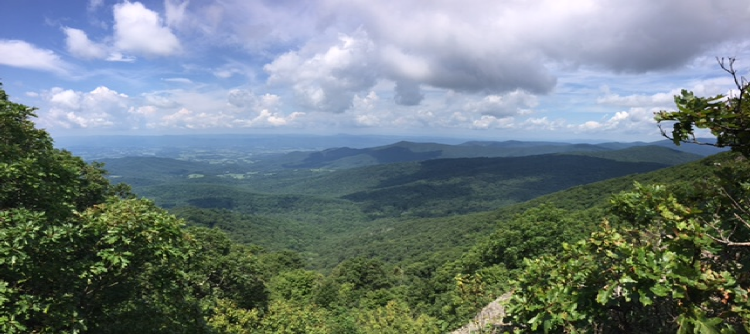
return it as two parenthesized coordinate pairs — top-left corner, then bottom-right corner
(320, 154), (731, 265)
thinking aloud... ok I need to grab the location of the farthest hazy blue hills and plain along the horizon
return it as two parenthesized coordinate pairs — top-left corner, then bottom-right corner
(55, 134), (722, 163)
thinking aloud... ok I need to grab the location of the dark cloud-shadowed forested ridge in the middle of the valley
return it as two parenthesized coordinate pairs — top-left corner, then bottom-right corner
(334, 154), (668, 217)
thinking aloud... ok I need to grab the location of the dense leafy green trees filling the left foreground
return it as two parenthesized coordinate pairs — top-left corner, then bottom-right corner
(0, 83), (274, 333)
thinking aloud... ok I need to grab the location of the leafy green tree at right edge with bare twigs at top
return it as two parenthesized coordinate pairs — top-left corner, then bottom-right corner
(507, 59), (750, 333)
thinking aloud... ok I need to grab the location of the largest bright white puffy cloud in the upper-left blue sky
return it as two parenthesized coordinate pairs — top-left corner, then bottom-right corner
(114, 2), (181, 56)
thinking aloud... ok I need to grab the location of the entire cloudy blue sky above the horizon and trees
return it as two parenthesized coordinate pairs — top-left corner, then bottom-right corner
(0, 0), (750, 141)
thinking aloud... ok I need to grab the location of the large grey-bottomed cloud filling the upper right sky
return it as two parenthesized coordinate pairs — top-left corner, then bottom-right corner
(268, 0), (750, 109)
